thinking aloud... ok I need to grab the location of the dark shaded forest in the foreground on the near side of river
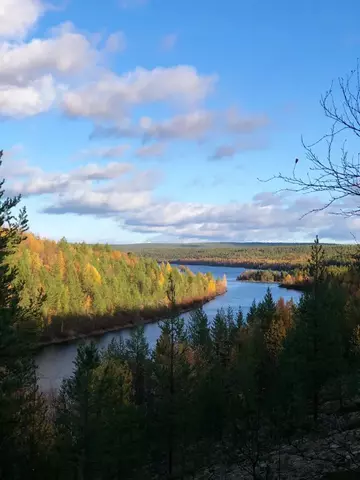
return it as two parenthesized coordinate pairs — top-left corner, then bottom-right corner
(4, 226), (360, 480)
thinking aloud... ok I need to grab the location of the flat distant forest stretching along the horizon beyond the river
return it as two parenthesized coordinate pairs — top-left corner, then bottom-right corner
(112, 243), (356, 270)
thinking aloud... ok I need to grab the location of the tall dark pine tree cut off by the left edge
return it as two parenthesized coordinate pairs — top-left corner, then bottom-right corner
(0, 151), (43, 480)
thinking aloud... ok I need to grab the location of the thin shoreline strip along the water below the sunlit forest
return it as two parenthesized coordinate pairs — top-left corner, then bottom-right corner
(35, 288), (227, 350)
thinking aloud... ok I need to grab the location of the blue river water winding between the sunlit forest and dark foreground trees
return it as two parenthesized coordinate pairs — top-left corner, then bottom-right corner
(36, 265), (300, 391)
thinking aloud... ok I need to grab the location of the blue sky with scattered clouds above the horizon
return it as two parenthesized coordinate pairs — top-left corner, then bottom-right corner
(0, 0), (360, 243)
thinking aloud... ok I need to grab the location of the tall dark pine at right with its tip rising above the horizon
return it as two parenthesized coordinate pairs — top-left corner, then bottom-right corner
(282, 238), (345, 421)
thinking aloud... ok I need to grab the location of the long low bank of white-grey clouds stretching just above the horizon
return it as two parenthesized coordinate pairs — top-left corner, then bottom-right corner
(14, 156), (354, 241)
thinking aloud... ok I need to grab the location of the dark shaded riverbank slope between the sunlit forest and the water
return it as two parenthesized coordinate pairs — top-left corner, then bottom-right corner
(37, 285), (227, 349)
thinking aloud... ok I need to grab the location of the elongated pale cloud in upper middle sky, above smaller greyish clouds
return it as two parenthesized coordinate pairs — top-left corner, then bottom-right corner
(63, 65), (216, 121)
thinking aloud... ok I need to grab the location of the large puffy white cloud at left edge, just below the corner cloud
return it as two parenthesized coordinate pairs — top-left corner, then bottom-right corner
(0, 17), (124, 118)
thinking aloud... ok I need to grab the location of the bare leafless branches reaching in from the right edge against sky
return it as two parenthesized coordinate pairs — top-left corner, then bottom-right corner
(268, 62), (360, 218)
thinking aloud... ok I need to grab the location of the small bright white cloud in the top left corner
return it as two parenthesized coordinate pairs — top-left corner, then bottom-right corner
(0, 0), (45, 39)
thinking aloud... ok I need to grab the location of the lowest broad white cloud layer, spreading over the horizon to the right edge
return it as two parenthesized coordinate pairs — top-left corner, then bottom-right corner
(31, 161), (360, 241)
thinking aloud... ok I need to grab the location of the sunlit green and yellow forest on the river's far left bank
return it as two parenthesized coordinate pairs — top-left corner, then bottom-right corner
(9, 233), (226, 342)
